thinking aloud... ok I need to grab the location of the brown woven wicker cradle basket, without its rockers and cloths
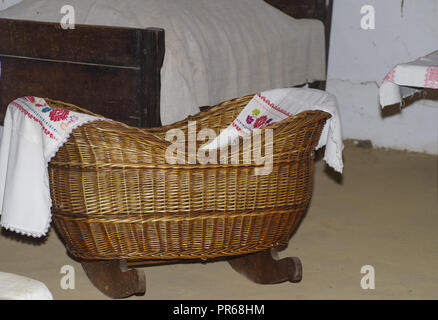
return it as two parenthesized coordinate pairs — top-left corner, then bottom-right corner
(47, 96), (330, 261)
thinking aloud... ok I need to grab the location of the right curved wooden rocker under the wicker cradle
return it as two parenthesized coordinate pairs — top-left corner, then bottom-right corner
(228, 248), (303, 284)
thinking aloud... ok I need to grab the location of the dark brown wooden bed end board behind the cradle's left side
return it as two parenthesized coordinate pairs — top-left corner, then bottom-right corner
(0, 19), (164, 126)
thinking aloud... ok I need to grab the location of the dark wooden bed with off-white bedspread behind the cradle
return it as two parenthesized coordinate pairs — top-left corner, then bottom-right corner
(0, 0), (332, 127)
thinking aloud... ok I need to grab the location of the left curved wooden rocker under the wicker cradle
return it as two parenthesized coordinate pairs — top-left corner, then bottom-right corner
(81, 260), (146, 299)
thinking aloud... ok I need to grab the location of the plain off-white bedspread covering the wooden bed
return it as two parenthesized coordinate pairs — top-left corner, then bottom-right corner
(0, 0), (325, 124)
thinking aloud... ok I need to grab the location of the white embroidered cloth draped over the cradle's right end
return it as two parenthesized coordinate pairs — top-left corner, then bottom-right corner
(202, 88), (344, 172)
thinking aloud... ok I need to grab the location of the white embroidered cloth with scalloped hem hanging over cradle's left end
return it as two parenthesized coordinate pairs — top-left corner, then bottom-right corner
(0, 97), (102, 237)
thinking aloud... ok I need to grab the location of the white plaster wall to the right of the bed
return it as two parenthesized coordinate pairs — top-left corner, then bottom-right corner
(327, 0), (438, 154)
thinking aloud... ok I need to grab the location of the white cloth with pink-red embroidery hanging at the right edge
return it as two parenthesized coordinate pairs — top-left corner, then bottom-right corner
(380, 50), (438, 108)
